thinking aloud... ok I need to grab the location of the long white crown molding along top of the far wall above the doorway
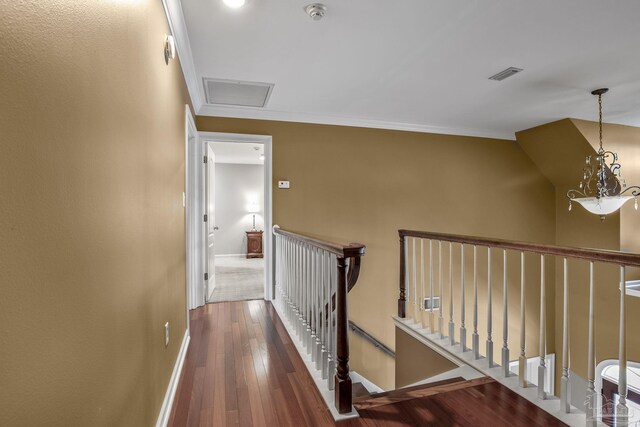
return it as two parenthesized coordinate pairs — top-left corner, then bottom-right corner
(198, 105), (515, 141)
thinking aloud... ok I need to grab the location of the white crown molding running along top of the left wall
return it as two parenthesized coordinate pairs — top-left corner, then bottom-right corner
(162, 0), (204, 114)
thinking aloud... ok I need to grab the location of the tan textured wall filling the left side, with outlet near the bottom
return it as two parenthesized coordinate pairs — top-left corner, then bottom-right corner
(0, 0), (187, 427)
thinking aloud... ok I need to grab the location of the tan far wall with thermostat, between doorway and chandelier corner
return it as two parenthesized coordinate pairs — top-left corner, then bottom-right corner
(196, 117), (555, 390)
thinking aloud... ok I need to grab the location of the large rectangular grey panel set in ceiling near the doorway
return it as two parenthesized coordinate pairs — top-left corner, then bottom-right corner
(203, 77), (273, 108)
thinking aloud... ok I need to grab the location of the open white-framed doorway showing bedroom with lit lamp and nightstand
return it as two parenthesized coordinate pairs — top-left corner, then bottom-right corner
(199, 132), (273, 302)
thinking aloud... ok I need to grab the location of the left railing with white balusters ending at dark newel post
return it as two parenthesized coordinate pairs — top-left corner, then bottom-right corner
(273, 225), (365, 414)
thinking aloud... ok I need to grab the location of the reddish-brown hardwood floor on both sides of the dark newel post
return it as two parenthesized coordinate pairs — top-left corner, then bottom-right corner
(169, 301), (564, 427)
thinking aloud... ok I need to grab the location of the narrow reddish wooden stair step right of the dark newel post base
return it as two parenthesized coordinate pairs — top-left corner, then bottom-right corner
(353, 377), (495, 410)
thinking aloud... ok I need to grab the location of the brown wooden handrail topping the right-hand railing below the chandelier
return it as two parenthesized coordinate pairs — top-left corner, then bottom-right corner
(398, 230), (640, 267)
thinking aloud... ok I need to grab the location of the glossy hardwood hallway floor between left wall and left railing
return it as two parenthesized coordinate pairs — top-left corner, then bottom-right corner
(169, 300), (334, 427)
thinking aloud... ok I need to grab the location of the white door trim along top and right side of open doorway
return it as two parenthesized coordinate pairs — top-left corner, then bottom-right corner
(194, 132), (274, 301)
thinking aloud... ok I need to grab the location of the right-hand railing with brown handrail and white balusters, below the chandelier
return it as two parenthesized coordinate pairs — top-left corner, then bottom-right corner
(398, 230), (640, 426)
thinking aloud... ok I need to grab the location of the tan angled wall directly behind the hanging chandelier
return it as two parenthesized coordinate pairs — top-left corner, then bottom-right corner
(516, 119), (640, 392)
